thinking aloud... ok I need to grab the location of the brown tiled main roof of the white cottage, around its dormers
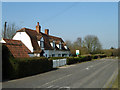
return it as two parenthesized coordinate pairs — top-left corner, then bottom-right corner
(17, 28), (69, 51)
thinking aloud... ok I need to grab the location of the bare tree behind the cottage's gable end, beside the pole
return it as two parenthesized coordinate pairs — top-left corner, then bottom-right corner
(2, 23), (20, 39)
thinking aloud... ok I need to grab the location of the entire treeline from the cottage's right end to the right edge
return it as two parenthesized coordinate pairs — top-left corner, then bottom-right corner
(66, 35), (118, 56)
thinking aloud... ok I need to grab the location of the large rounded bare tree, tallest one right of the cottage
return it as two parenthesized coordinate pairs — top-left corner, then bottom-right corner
(84, 35), (102, 54)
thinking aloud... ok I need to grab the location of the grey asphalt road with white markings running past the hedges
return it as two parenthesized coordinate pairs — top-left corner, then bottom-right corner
(2, 59), (118, 89)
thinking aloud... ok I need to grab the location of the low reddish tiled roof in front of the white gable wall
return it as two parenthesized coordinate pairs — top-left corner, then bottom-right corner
(3, 39), (31, 58)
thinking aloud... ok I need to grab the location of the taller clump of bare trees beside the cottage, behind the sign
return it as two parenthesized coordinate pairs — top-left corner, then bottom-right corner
(66, 35), (102, 56)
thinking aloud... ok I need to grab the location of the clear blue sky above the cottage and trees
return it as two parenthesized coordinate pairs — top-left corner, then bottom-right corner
(2, 2), (118, 49)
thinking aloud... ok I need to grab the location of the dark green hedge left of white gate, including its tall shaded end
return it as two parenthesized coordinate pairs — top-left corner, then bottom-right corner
(2, 45), (52, 79)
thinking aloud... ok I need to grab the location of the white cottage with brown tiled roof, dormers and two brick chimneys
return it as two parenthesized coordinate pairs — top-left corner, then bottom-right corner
(13, 22), (70, 57)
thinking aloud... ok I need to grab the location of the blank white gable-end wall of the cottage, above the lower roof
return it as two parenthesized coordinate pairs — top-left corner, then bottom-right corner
(13, 32), (33, 52)
